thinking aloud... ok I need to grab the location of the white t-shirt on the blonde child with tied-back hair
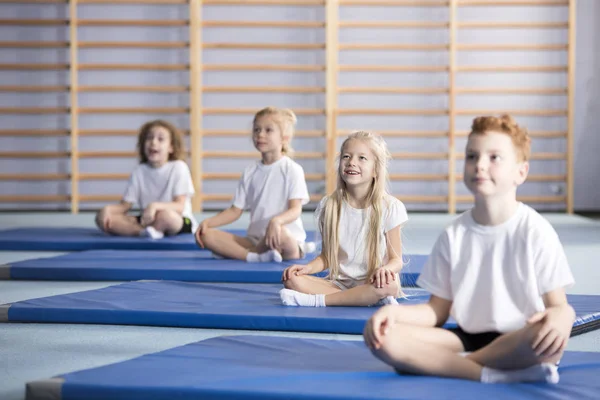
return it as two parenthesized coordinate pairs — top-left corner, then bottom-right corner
(233, 156), (309, 242)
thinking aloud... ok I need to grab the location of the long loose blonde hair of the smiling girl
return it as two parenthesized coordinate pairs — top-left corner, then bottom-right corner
(319, 131), (391, 280)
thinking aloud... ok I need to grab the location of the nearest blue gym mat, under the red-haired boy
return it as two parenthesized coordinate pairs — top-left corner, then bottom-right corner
(26, 336), (600, 400)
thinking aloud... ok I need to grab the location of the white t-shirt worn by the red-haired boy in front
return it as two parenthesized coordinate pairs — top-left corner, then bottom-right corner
(417, 203), (574, 333)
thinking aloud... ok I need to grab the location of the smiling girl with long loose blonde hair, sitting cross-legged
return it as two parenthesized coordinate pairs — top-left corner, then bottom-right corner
(280, 132), (408, 307)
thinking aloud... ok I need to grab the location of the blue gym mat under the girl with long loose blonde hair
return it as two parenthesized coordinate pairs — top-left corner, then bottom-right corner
(0, 281), (600, 334)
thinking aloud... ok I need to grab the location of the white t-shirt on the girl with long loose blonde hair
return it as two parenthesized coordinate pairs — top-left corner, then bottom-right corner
(315, 195), (408, 286)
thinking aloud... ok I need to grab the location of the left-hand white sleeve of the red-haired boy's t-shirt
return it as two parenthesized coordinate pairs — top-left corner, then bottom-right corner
(417, 231), (453, 300)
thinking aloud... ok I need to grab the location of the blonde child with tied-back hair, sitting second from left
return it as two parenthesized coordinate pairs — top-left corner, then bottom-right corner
(196, 107), (315, 262)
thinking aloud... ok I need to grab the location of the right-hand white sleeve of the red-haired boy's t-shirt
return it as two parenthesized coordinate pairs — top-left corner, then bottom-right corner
(532, 224), (575, 295)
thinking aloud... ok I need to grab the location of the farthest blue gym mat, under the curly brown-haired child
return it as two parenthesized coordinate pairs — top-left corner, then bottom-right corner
(0, 227), (315, 251)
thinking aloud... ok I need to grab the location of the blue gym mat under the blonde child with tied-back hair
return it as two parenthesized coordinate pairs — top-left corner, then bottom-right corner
(0, 250), (427, 286)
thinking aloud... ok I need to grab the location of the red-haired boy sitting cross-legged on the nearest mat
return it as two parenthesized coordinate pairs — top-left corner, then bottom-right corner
(364, 115), (575, 383)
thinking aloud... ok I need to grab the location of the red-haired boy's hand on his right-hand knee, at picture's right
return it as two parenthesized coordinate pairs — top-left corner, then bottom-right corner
(527, 306), (574, 359)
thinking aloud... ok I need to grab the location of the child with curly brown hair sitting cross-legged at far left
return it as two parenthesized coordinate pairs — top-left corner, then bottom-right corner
(96, 120), (198, 239)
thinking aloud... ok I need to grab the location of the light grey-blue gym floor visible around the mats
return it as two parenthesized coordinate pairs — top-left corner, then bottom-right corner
(0, 213), (600, 400)
